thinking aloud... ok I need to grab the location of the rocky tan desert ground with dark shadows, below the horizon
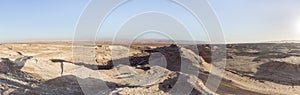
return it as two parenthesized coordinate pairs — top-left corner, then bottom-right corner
(0, 43), (300, 95)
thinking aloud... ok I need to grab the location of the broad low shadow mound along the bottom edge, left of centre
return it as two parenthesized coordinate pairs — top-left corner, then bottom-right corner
(11, 75), (137, 95)
